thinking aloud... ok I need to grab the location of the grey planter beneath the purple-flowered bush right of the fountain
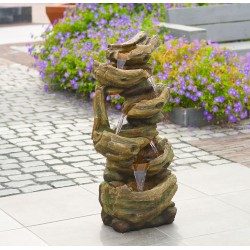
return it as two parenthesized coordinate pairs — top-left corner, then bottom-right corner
(168, 107), (221, 127)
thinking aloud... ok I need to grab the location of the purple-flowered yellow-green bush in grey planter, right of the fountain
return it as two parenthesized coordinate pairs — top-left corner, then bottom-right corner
(153, 37), (250, 122)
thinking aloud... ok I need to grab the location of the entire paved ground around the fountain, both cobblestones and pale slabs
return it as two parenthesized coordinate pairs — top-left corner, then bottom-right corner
(0, 23), (250, 246)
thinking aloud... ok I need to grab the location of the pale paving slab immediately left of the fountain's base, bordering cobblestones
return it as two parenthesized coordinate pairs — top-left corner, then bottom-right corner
(0, 186), (101, 226)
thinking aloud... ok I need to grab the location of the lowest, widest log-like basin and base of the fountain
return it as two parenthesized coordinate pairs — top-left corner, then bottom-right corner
(99, 174), (177, 233)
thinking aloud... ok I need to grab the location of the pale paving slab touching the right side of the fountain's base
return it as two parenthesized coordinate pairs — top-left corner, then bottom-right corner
(158, 196), (250, 240)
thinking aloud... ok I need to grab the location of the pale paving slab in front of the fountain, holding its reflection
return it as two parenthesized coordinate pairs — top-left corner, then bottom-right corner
(26, 214), (174, 246)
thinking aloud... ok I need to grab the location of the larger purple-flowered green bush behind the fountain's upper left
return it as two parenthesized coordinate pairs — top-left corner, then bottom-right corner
(29, 3), (164, 108)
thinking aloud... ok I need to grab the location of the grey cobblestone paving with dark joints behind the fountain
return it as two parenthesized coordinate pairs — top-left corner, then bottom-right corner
(0, 59), (250, 197)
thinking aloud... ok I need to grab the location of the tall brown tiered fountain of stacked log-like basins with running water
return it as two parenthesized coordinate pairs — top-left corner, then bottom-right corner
(92, 32), (177, 232)
